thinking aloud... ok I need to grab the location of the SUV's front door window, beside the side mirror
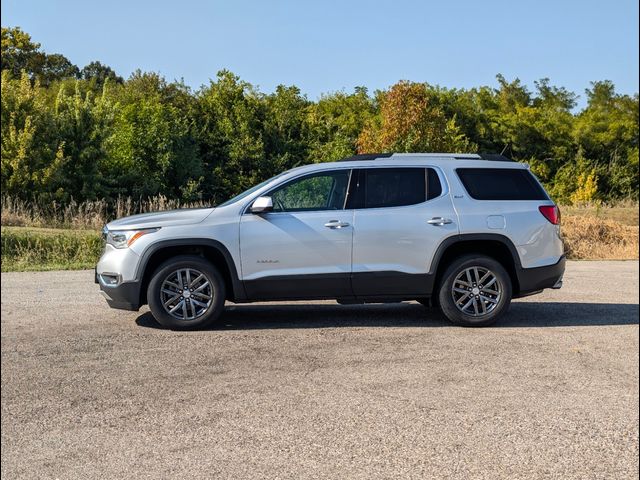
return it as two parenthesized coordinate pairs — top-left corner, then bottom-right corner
(269, 170), (349, 212)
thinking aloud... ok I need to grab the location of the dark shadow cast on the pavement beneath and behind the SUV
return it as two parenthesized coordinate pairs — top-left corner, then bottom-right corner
(136, 301), (639, 330)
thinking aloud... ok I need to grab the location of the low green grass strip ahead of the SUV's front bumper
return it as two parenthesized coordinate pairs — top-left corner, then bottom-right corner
(0, 226), (103, 272)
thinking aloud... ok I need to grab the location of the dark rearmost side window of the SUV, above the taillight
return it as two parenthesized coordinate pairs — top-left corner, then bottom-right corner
(456, 168), (549, 200)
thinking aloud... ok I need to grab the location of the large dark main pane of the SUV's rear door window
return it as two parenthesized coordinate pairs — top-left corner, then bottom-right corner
(348, 168), (426, 208)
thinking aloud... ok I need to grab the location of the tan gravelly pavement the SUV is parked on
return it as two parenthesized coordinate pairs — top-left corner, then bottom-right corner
(1, 262), (638, 479)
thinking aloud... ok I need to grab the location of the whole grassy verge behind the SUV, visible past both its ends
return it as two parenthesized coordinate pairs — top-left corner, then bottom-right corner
(1, 197), (639, 272)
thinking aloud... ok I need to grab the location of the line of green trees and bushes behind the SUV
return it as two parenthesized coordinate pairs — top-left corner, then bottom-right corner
(1, 27), (639, 204)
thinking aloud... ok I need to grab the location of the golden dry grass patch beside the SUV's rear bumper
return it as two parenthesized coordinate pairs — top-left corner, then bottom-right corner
(562, 214), (638, 260)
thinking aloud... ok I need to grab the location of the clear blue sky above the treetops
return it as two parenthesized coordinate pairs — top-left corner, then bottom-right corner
(2, 0), (639, 103)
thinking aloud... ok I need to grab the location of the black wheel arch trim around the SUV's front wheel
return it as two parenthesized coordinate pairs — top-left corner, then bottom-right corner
(136, 238), (245, 305)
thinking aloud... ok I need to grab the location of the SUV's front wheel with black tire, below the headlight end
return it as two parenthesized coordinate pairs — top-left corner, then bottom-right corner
(147, 255), (226, 330)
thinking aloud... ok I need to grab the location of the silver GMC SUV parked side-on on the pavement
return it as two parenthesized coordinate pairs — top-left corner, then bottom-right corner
(96, 153), (565, 329)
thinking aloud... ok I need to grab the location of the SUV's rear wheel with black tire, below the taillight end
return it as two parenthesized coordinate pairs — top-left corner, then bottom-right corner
(437, 255), (512, 327)
